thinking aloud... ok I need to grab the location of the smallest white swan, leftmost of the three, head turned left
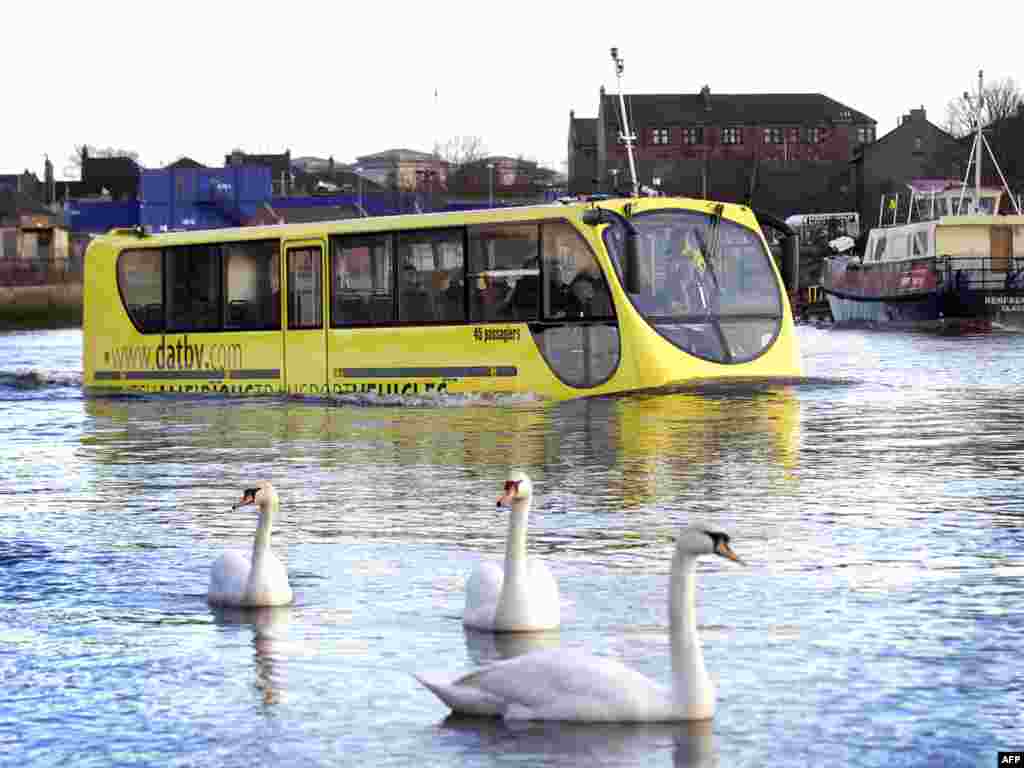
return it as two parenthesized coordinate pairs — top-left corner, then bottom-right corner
(207, 480), (292, 608)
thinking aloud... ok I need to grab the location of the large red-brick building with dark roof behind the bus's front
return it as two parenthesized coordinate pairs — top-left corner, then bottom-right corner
(569, 85), (876, 213)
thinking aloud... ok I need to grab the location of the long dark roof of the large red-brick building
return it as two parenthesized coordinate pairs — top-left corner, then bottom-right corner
(601, 86), (876, 126)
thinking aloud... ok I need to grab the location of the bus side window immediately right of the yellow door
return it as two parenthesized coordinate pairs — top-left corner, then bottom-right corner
(331, 234), (394, 327)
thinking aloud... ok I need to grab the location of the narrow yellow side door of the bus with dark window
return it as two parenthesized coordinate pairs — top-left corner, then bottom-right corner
(284, 240), (328, 394)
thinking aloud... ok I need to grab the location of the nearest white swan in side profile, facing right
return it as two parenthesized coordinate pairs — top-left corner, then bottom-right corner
(416, 527), (742, 723)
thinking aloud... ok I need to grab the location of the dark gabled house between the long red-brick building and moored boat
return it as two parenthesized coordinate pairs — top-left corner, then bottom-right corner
(850, 106), (970, 230)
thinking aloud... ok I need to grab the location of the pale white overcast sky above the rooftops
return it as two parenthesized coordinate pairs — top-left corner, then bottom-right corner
(0, 0), (1024, 179)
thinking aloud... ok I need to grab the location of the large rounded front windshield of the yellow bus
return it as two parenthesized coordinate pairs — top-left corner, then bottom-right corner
(604, 210), (782, 362)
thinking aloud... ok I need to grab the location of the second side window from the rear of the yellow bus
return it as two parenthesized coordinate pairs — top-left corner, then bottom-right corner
(164, 245), (222, 332)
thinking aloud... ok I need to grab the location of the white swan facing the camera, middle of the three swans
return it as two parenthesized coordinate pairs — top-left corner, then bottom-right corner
(462, 472), (560, 632)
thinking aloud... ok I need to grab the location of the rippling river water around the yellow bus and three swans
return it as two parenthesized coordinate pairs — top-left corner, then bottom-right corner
(0, 327), (1024, 768)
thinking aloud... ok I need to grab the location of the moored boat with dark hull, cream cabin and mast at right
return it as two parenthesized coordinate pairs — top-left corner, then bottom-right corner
(822, 73), (1024, 333)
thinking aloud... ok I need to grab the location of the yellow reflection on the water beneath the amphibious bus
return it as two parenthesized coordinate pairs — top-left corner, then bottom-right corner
(83, 382), (801, 506)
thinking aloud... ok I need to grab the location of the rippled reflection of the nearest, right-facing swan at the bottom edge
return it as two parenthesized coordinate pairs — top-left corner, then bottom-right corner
(440, 715), (719, 768)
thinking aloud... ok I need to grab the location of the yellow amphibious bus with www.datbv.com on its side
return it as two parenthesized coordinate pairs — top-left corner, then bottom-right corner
(83, 198), (801, 399)
